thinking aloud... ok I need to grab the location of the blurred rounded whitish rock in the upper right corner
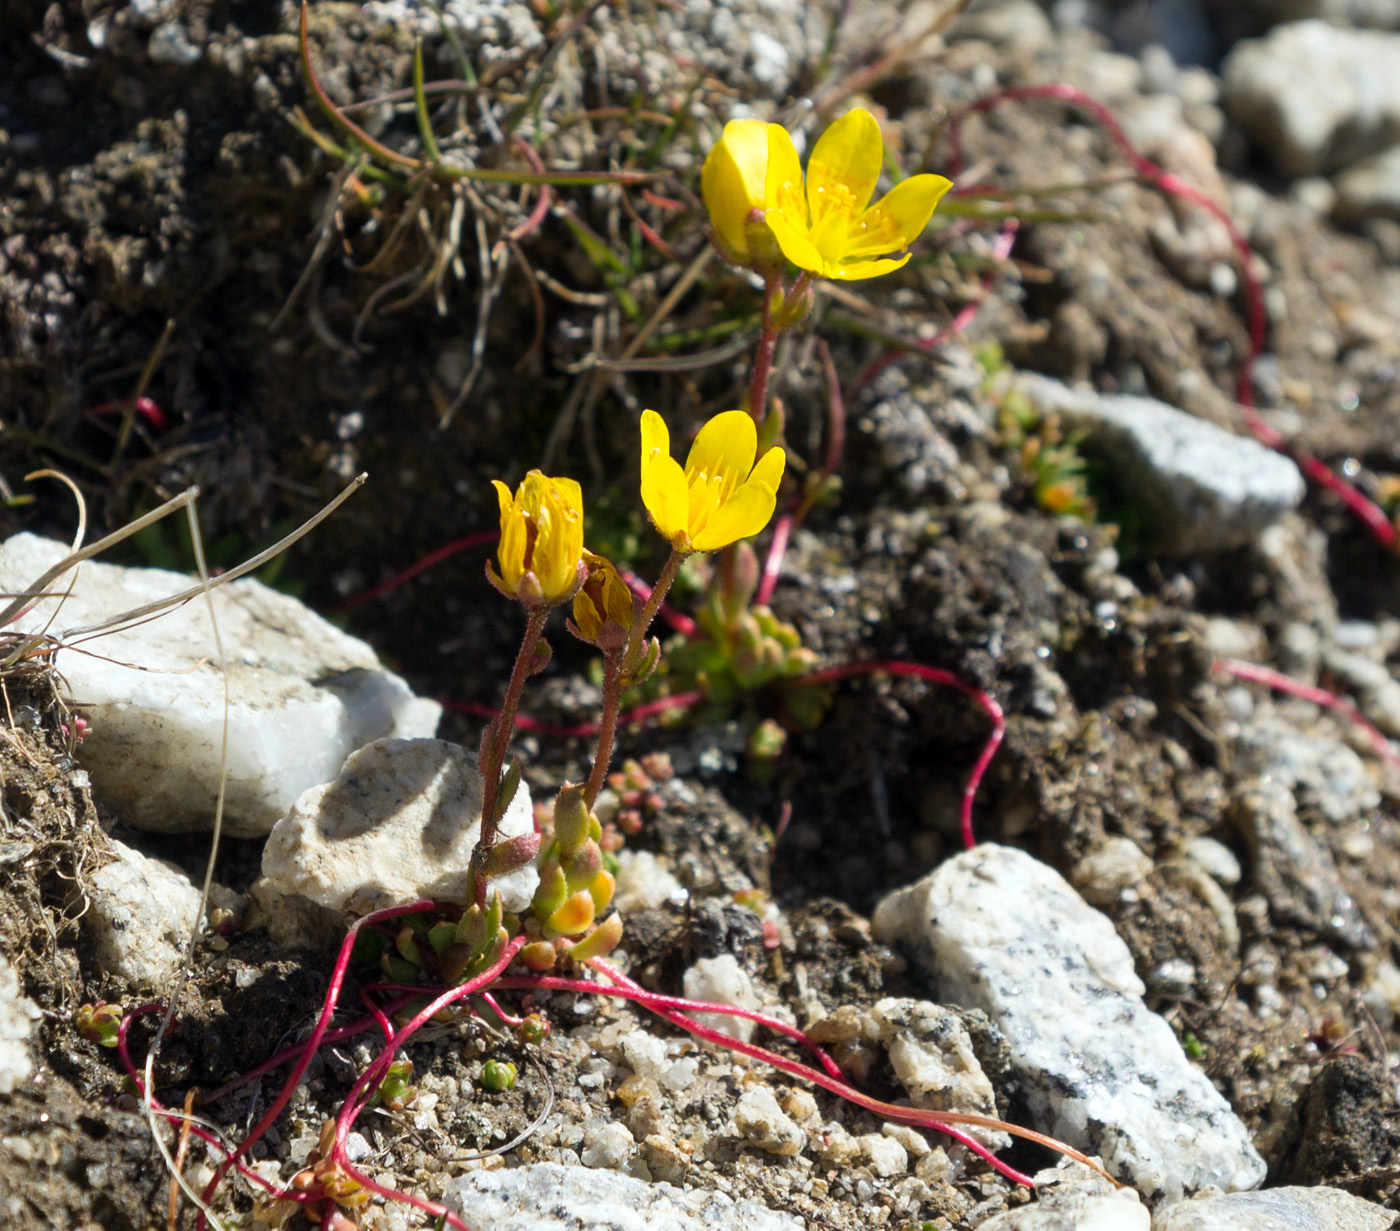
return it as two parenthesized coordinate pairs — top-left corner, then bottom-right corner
(1221, 21), (1400, 175)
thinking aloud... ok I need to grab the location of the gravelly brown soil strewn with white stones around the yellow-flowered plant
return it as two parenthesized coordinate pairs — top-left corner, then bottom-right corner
(0, 0), (1400, 1231)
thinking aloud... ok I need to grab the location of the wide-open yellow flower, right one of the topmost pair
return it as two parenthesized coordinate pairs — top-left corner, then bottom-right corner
(763, 108), (952, 280)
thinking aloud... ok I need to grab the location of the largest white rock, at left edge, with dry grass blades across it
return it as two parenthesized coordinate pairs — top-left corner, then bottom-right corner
(0, 534), (441, 837)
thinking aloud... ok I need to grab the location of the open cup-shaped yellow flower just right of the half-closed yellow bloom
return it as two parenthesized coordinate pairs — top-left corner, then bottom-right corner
(641, 410), (787, 552)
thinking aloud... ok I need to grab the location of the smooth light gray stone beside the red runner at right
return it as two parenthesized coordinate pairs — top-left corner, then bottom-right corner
(1016, 375), (1303, 556)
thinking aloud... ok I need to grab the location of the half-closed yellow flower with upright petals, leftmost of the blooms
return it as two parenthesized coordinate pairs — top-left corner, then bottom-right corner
(491, 471), (584, 606)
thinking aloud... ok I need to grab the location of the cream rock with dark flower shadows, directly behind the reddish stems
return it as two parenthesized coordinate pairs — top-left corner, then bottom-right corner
(263, 739), (539, 914)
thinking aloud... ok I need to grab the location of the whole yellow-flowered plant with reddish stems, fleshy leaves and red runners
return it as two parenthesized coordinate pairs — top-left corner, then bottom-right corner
(126, 103), (1120, 1231)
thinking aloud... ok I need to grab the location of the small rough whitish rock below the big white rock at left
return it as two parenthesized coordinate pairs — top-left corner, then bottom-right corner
(83, 842), (199, 989)
